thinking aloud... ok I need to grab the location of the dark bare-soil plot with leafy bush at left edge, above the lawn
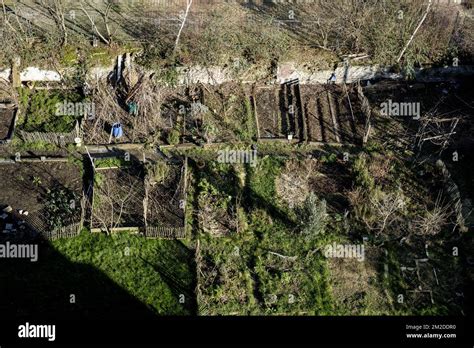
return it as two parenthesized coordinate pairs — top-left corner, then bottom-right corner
(0, 160), (83, 239)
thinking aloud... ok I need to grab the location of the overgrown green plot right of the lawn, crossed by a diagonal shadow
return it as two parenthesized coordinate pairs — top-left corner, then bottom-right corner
(189, 157), (344, 315)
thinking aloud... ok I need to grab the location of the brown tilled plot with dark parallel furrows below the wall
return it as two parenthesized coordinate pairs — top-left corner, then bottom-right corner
(254, 80), (367, 144)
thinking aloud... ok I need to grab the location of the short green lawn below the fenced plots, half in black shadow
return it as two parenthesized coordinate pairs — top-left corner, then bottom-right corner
(0, 232), (195, 319)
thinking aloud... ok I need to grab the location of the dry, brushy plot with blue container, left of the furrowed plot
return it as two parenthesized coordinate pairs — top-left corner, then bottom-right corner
(84, 68), (254, 145)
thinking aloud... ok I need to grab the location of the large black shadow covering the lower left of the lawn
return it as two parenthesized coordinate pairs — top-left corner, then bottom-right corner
(0, 235), (161, 321)
